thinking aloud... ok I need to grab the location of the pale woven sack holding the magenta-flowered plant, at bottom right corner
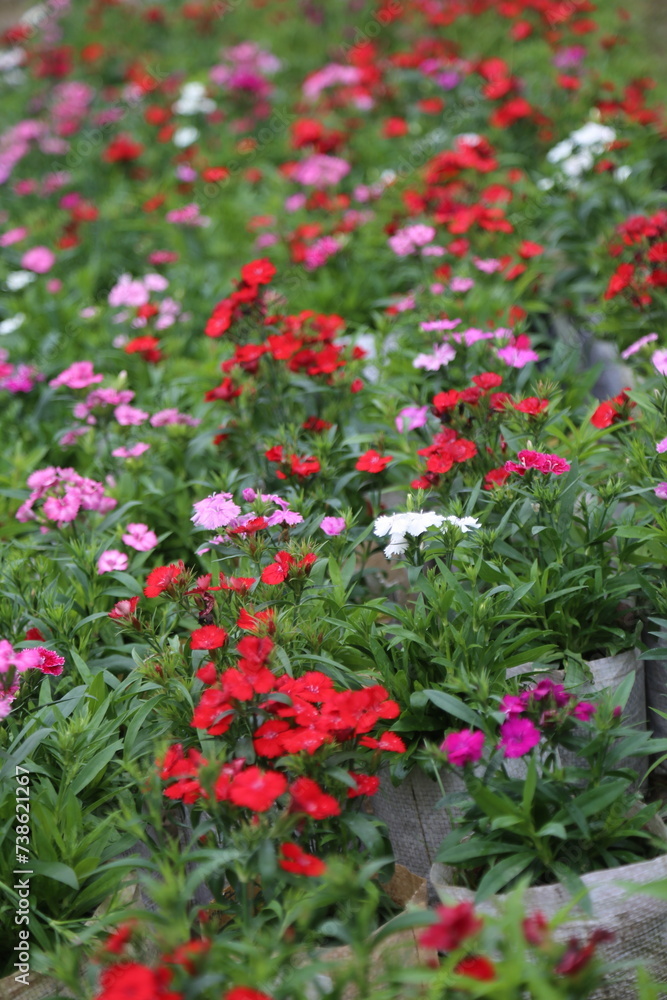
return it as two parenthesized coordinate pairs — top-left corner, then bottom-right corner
(430, 817), (667, 1000)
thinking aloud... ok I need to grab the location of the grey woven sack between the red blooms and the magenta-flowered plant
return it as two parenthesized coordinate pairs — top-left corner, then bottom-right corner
(372, 767), (465, 878)
